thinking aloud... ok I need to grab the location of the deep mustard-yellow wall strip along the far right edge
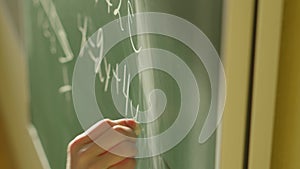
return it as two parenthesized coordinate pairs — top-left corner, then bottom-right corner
(272, 0), (300, 169)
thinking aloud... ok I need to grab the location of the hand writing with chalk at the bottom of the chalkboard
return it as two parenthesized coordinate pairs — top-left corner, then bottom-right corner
(67, 119), (138, 169)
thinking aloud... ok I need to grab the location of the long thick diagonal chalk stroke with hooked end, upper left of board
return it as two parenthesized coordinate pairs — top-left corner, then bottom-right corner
(40, 0), (74, 63)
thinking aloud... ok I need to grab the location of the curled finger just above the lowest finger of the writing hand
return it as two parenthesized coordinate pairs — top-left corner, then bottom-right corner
(90, 141), (137, 169)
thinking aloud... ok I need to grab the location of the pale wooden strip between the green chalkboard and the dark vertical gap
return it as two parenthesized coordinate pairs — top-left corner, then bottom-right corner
(220, 0), (255, 169)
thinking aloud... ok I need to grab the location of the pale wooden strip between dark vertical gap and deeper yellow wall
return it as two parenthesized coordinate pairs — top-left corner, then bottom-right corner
(248, 0), (283, 169)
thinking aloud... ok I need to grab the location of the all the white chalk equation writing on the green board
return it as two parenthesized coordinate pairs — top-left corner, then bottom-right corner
(33, 0), (141, 119)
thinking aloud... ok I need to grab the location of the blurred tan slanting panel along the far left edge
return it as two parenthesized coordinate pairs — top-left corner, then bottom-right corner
(0, 6), (47, 169)
